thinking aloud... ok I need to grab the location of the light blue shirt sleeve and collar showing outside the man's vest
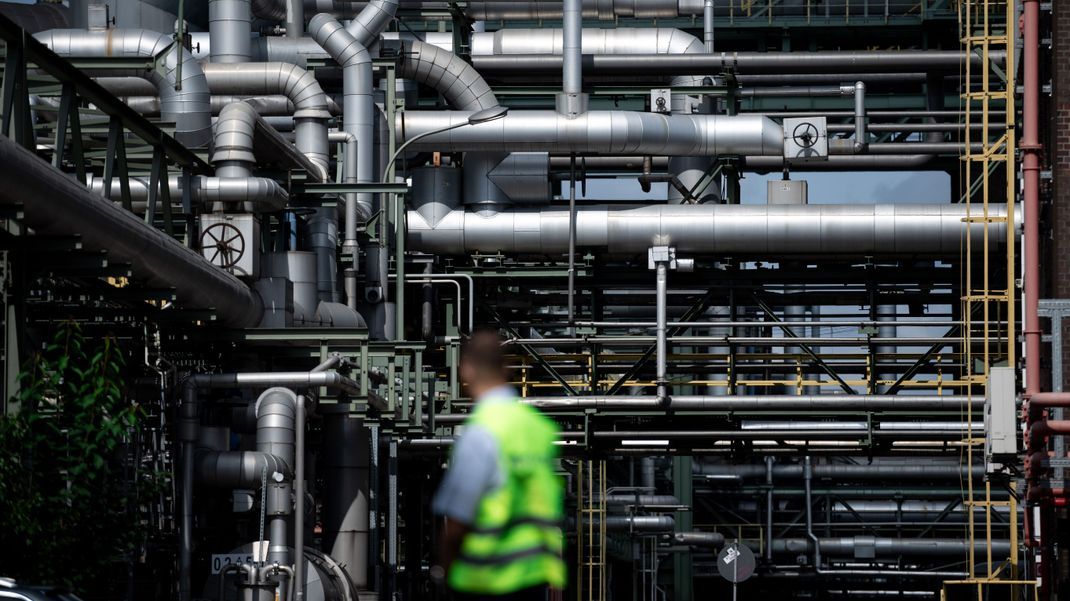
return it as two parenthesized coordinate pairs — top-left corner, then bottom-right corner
(431, 385), (517, 525)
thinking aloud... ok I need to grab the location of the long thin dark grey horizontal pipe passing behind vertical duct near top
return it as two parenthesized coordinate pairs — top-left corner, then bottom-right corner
(472, 49), (1006, 75)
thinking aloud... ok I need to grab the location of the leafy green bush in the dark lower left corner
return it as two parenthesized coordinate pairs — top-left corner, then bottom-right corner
(0, 323), (153, 597)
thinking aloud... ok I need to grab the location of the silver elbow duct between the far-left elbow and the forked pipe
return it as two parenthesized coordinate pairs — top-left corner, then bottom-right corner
(204, 62), (331, 180)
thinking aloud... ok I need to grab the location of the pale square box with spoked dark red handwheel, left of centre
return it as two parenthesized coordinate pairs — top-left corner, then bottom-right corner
(199, 213), (260, 279)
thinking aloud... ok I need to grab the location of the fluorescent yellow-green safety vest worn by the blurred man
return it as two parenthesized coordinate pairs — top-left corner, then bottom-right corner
(448, 395), (566, 595)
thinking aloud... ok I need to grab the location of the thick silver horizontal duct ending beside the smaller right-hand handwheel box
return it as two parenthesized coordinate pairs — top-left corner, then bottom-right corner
(398, 110), (783, 156)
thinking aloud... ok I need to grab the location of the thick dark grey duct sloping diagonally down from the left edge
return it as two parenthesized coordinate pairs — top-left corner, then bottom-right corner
(0, 136), (263, 327)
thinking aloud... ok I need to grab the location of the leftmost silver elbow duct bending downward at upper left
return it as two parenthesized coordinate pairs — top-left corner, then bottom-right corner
(34, 29), (212, 148)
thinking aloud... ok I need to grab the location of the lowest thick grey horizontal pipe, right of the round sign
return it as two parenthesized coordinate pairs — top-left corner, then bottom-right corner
(773, 536), (1011, 556)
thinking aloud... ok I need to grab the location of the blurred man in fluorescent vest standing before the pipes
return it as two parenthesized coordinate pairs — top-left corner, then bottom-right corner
(431, 330), (565, 601)
